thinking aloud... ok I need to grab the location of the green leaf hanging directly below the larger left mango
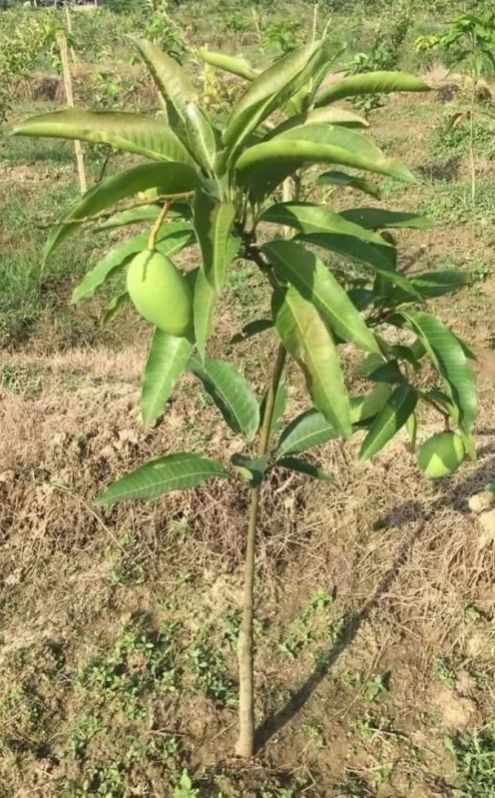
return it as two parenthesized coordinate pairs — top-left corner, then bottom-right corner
(141, 329), (193, 425)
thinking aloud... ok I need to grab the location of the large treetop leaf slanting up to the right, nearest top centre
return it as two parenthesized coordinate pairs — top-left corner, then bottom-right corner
(223, 42), (321, 150)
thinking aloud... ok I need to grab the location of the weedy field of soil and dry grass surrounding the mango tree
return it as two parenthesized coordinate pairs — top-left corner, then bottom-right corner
(0, 0), (495, 798)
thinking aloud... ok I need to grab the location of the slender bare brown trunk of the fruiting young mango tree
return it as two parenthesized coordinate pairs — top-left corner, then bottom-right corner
(236, 345), (286, 759)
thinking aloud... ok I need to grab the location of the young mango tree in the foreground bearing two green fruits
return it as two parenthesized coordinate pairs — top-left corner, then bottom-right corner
(14, 40), (475, 757)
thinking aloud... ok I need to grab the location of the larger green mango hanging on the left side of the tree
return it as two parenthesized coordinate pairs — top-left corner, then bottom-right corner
(127, 249), (193, 337)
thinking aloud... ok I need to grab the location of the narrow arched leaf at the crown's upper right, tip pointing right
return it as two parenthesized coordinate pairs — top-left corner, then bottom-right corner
(315, 71), (430, 108)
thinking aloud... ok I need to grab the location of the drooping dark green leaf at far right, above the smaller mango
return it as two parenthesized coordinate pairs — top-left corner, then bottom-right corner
(401, 311), (476, 435)
